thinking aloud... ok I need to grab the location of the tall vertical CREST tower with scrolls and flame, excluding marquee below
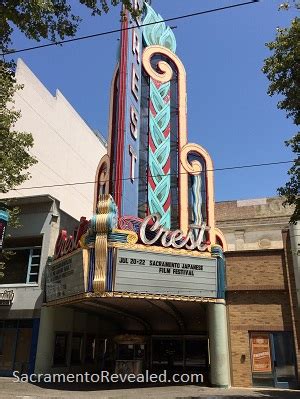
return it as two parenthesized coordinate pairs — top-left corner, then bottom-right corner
(95, 1), (222, 248)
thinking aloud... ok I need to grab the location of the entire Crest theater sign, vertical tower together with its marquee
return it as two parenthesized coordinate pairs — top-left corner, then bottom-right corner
(47, 1), (225, 301)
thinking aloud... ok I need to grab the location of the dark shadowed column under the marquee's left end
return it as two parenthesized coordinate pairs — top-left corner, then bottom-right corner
(35, 306), (55, 374)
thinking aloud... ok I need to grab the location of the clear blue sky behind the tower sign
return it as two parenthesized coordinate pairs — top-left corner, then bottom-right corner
(7, 0), (296, 201)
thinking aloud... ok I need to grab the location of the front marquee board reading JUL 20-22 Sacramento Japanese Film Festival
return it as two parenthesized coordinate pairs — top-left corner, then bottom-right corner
(114, 249), (218, 298)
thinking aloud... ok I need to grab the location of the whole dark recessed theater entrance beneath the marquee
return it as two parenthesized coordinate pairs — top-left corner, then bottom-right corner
(36, 297), (227, 386)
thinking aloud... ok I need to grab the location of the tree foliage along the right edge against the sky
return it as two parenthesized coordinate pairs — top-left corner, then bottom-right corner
(262, 1), (300, 223)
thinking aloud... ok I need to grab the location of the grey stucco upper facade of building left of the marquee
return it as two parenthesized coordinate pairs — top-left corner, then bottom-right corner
(0, 196), (78, 319)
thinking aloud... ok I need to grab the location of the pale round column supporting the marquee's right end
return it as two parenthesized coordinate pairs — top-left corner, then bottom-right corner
(208, 303), (230, 388)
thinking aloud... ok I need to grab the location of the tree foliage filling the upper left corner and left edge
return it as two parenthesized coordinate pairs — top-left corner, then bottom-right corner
(0, 0), (138, 193)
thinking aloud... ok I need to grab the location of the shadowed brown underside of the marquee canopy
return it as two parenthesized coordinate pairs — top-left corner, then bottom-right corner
(48, 294), (216, 335)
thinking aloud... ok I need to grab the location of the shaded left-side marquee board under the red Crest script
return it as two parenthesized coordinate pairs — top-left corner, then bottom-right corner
(46, 249), (87, 302)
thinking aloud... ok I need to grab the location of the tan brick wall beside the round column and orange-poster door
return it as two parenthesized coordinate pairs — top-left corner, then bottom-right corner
(226, 250), (293, 387)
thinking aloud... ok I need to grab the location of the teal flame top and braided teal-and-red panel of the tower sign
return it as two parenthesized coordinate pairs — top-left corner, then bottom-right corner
(143, 3), (176, 228)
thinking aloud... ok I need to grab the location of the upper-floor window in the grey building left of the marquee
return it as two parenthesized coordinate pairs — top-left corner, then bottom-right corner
(1, 246), (42, 284)
